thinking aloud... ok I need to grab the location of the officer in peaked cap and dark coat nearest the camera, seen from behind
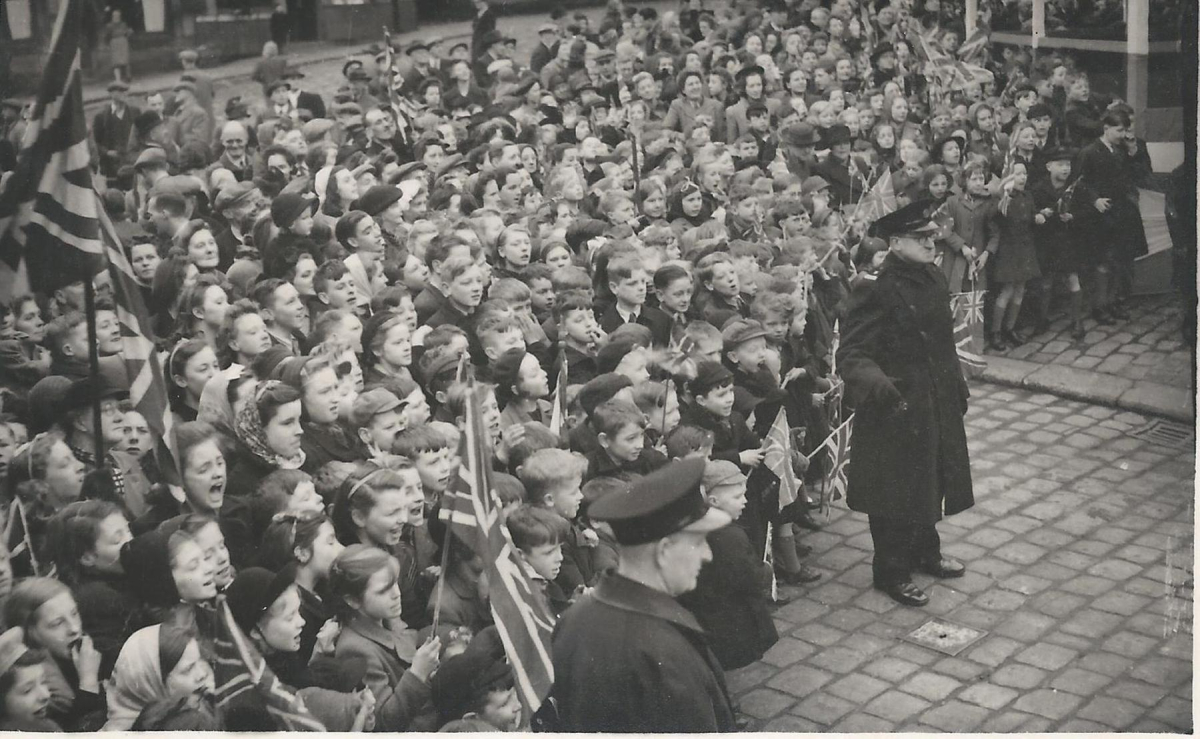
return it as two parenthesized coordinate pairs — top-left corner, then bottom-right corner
(542, 459), (737, 733)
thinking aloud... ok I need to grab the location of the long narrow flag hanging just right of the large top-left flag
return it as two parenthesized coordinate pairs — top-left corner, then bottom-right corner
(99, 201), (179, 482)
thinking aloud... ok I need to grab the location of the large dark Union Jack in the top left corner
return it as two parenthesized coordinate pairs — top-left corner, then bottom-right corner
(0, 0), (103, 295)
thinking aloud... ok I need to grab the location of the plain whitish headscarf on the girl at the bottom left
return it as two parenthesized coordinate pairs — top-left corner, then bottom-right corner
(101, 624), (194, 732)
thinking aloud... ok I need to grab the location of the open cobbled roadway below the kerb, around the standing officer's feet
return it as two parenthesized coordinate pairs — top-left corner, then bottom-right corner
(730, 385), (1195, 732)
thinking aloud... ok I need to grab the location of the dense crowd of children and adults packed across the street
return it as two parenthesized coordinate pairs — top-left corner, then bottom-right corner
(0, 0), (1148, 731)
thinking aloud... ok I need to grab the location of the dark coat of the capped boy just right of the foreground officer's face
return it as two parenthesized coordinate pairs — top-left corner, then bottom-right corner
(679, 524), (779, 669)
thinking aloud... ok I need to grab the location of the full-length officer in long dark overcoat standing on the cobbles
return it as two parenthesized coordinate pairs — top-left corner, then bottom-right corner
(838, 200), (974, 606)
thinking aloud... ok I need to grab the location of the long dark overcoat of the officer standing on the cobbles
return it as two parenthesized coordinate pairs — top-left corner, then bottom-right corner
(838, 254), (974, 524)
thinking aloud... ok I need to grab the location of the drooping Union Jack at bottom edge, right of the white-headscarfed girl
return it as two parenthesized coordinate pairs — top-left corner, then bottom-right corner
(212, 596), (325, 732)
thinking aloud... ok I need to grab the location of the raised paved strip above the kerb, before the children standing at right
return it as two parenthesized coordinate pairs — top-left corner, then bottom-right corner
(1001, 293), (1192, 387)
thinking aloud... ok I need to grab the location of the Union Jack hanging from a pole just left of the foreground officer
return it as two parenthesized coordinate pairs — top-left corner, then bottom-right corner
(440, 389), (554, 716)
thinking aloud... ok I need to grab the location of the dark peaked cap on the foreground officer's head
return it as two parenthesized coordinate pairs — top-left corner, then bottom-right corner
(588, 459), (733, 546)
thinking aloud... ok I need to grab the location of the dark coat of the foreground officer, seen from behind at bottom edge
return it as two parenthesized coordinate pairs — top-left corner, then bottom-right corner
(548, 575), (736, 733)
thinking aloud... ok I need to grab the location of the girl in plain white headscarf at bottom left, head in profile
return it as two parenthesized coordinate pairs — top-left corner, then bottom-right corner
(101, 624), (214, 732)
